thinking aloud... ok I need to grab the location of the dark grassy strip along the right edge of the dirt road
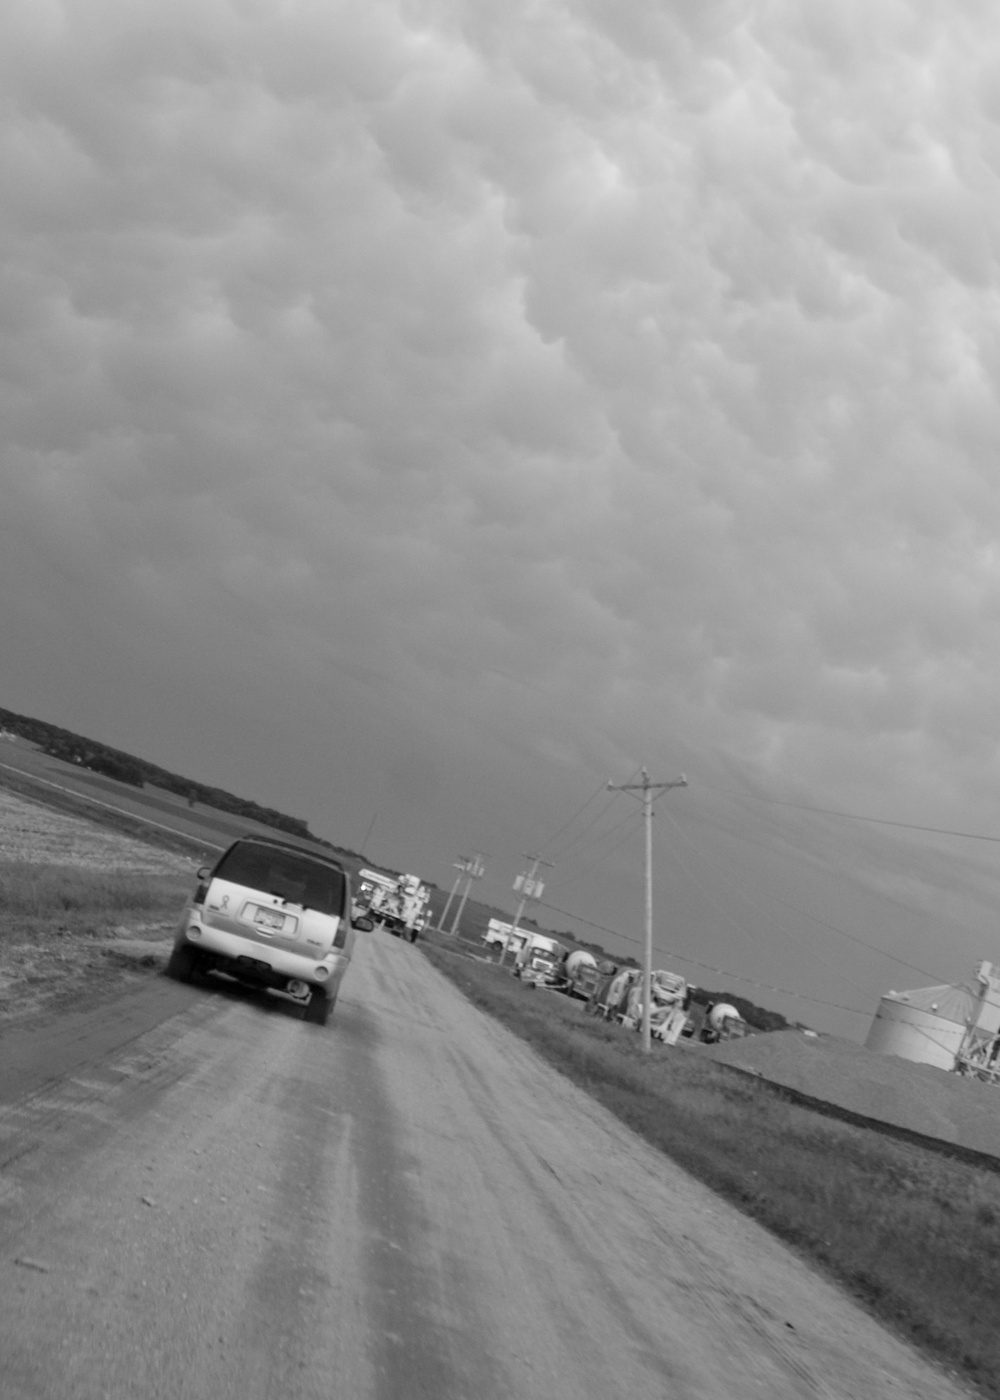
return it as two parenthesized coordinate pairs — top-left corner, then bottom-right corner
(422, 941), (1000, 1397)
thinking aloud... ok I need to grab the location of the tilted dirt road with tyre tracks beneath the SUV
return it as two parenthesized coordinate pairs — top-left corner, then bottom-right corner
(0, 935), (965, 1400)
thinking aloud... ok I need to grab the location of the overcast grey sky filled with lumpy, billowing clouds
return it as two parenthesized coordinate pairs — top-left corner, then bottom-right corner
(0, 0), (1000, 1037)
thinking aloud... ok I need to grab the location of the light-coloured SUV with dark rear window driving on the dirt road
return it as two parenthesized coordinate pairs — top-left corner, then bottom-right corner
(167, 836), (373, 1025)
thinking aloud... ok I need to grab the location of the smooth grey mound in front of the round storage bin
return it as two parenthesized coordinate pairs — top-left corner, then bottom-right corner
(700, 1030), (1000, 1158)
